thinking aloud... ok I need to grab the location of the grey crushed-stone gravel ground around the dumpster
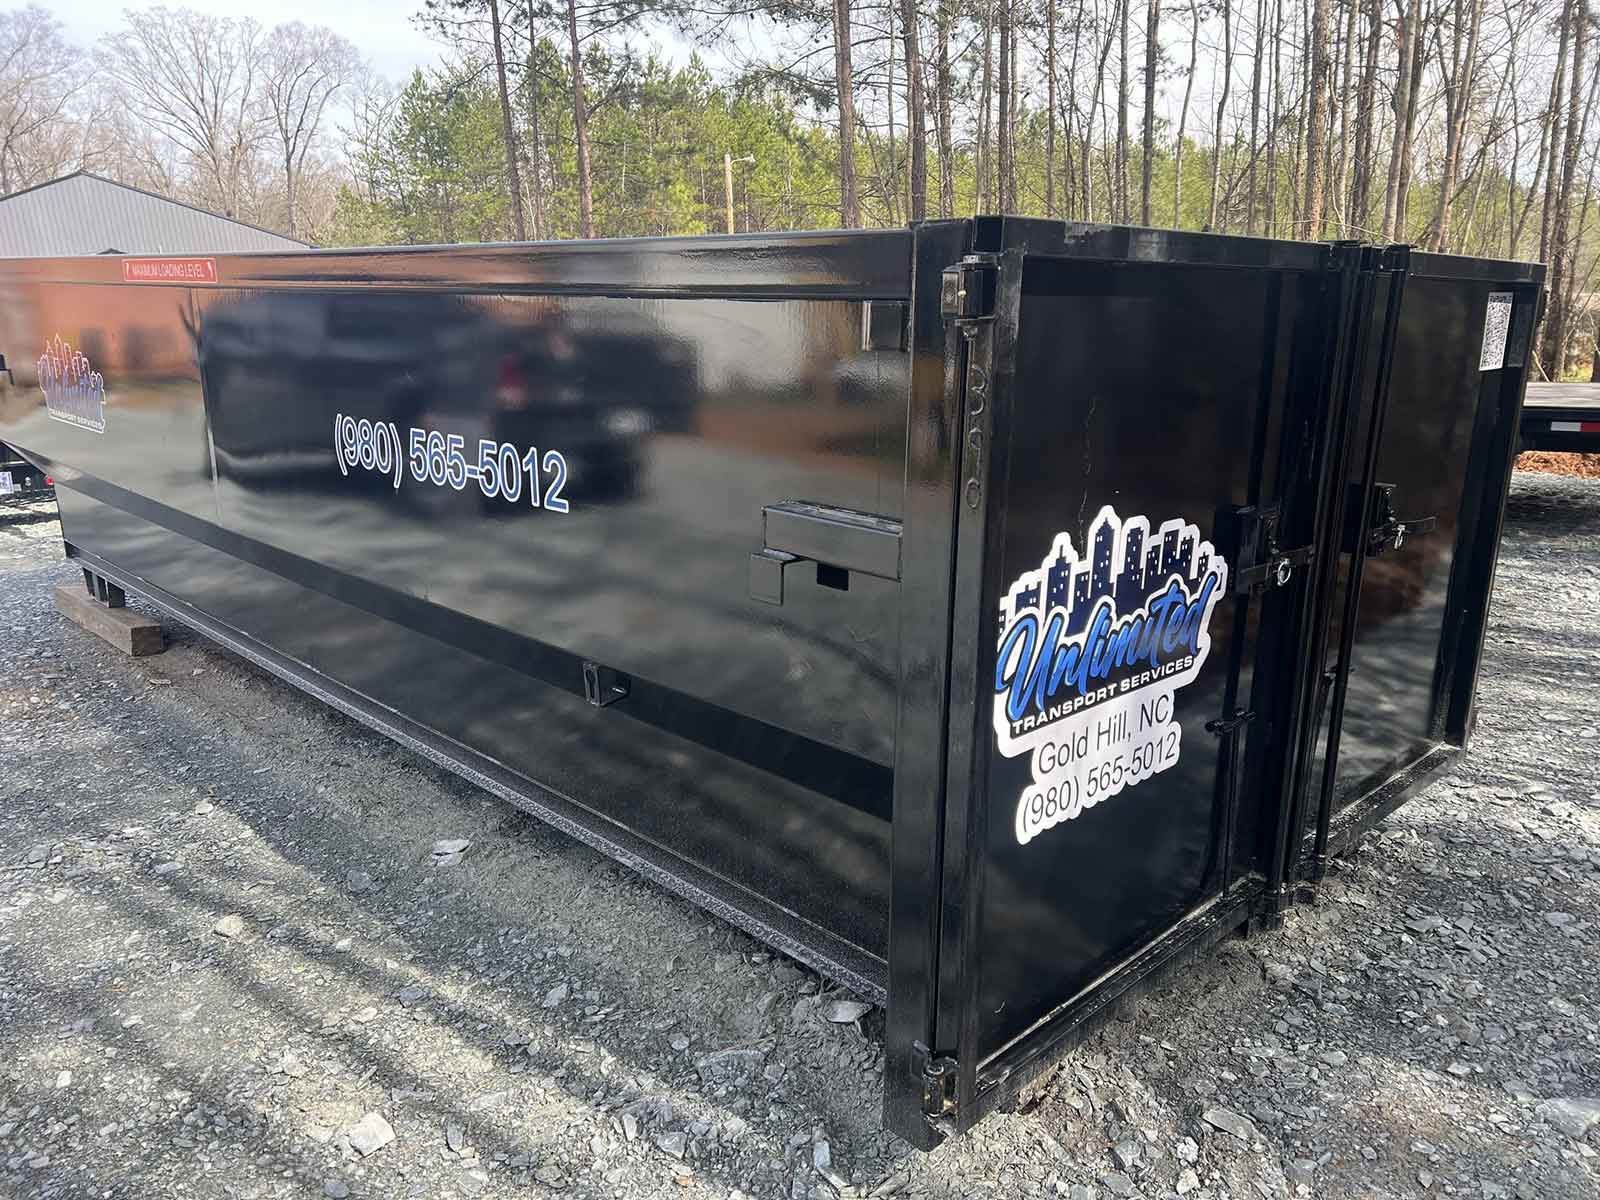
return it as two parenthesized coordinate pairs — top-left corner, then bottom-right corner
(0, 474), (1600, 1200)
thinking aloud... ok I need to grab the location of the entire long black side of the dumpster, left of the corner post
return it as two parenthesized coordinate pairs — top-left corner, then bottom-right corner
(0, 230), (910, 997)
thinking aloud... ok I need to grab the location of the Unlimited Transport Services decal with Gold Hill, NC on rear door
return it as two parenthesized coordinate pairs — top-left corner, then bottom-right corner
(994, 504), (1227, 845)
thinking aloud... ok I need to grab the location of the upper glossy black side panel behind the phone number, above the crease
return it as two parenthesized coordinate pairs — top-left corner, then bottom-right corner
(200, 290), (909, 771)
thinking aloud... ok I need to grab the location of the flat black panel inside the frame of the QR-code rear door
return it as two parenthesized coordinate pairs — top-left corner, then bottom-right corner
(1330, 270), (1536, 814)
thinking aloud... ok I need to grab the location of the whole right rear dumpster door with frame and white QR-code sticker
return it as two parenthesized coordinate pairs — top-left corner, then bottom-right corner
(1310, 254), (1539, 844)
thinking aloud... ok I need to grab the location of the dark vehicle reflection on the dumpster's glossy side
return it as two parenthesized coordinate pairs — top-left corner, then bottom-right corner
(197, 293), (686, 498)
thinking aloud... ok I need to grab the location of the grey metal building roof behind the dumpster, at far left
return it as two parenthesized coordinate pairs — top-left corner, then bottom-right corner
(0, 171), (307, 258)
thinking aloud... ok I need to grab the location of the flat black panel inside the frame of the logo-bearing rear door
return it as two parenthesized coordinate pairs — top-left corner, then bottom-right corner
(941, 248), (1336, 1068)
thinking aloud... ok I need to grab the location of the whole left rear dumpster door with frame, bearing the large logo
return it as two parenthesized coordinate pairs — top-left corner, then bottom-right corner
(891, 222), (1355, 1128)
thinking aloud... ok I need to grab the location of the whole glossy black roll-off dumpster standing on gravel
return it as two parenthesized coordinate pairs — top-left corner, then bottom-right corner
(0, 218), (1542, 1147)
